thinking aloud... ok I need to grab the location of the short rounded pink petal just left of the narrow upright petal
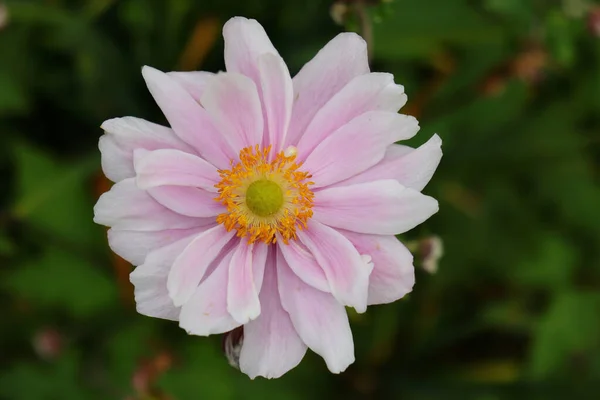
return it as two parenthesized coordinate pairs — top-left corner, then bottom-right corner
(201, 73), (263, 152)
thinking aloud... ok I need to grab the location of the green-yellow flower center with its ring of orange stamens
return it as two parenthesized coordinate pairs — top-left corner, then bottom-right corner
(215, 145), (314, 244)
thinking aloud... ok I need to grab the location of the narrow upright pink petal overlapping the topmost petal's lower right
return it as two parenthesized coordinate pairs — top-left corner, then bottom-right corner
(258, 53), (294, 154)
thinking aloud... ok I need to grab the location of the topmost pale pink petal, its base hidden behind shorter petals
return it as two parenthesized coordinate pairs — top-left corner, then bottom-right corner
(223, 17), (279, 86)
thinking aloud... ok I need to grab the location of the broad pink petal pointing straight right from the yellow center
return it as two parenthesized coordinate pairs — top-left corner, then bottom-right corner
(313, 179), (438, 235)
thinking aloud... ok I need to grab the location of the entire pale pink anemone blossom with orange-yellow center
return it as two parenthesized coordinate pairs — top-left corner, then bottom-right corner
(94, 18), (442, 378)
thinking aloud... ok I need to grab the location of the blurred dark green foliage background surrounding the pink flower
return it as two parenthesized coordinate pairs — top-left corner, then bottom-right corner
(0, 0), (600, 400)
